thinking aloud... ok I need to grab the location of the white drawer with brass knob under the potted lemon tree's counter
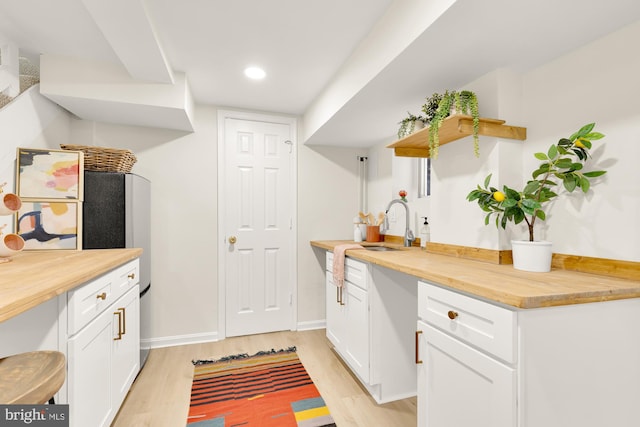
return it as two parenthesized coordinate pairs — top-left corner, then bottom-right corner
(418, 281), (516, 363)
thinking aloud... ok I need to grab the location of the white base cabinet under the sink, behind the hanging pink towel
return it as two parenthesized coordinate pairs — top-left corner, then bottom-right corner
(326, 252), (417, 403)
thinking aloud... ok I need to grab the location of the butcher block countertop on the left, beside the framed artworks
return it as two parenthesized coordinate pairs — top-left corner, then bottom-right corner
(0, 248), (142, 322)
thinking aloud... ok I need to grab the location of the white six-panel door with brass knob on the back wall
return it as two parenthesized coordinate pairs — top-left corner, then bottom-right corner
(221, 117), (294, 336)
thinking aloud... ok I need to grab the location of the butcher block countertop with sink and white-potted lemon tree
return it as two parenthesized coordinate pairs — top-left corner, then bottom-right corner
(311, 240), (640, 309)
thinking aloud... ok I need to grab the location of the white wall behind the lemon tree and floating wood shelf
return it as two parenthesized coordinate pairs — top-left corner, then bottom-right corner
(398, 22), (640, 261)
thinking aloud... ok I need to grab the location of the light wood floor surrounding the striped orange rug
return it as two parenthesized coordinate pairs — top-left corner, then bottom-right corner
(112, 329), (416, 427)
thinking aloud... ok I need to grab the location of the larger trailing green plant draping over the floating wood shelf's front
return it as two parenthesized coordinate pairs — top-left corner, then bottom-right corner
(429, 90), (480, 159)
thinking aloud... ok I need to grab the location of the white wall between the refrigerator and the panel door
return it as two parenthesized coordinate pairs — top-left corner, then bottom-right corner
(67, 106), (218, 346)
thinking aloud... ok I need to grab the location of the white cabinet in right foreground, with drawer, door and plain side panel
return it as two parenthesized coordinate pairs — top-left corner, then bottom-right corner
(417, 281), (640, 427)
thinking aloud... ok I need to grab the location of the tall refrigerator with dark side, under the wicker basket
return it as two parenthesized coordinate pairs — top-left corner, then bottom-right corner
(82, 171), (151, 368)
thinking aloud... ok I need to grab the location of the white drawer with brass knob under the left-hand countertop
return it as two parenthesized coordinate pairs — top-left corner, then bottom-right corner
(67, 271), (118, 335)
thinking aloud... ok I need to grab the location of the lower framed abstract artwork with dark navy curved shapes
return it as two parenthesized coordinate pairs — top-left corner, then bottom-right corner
(16, 200), (82, 250)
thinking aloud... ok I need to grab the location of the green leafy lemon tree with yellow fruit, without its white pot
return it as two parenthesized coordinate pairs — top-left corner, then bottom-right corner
(467, 123), (606, 242)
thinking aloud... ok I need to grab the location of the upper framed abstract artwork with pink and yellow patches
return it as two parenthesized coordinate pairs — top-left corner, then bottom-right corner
(16, 148), (84, 201)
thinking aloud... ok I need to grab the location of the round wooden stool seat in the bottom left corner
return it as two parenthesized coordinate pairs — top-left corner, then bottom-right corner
(0, 351), (66, 405)
